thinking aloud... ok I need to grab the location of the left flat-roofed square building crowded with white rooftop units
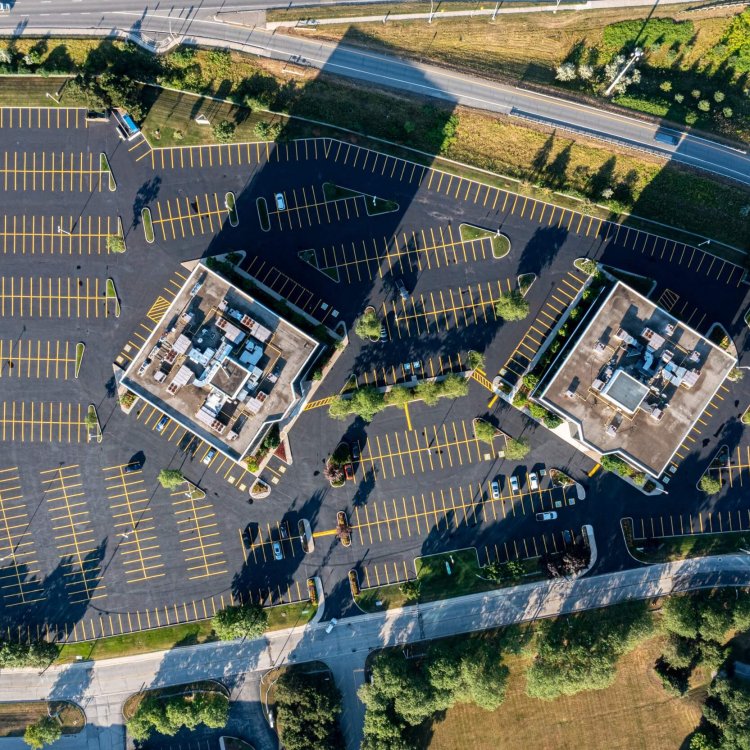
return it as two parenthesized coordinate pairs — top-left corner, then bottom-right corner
(122, 263), (319, 461)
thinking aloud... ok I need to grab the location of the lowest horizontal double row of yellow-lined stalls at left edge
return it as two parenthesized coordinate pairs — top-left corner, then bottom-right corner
(0, 401), (87, 443)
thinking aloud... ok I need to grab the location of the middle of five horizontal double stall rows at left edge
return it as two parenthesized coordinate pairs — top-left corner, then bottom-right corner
(0, 276), (117, 318)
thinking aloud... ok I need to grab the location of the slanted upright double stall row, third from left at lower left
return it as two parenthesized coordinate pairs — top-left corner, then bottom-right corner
(102, 464), (165, 583)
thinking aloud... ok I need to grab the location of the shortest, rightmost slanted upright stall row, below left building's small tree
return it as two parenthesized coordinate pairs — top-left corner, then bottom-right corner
(171, 489), (229, 581)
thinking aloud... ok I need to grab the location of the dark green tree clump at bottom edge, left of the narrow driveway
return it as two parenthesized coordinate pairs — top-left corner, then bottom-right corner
(275, 668), (344, 750)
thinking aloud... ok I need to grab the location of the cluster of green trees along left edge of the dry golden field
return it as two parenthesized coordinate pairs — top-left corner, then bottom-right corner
(359, 628), (520, 750)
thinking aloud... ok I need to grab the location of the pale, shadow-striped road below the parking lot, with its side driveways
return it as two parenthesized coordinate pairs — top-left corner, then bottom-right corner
(0, 556), (750, 750)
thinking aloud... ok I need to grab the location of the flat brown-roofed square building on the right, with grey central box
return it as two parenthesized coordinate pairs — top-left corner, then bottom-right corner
(537, 281), (736, 478)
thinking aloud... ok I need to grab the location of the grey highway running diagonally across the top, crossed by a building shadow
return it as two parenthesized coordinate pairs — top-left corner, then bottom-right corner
(0, 0), (750, 185)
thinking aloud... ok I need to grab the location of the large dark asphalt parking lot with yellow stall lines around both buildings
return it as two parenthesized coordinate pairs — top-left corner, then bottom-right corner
(0, 119), (750, 640)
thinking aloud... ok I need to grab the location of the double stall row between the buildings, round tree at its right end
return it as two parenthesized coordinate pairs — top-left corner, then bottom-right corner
(383, 279), (513, 341)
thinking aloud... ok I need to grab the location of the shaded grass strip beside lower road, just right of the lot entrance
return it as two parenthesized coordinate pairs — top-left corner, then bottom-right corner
(355, 549), (544, 612)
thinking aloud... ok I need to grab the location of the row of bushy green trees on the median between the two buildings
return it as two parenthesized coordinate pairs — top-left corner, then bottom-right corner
(328, 374), (469, 422)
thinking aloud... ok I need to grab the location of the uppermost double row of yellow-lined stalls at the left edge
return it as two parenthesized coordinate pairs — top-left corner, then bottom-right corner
(0, 151), (109, 193)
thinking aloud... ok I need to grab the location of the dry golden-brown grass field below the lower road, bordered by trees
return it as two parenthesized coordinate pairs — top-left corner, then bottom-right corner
(423, 639), (706, 750)
